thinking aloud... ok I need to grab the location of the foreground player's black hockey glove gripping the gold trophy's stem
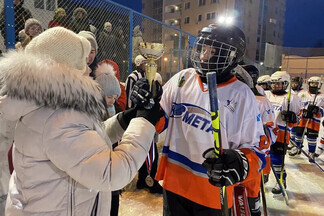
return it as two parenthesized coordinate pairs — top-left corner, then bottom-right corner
(130, 78), (163, 107)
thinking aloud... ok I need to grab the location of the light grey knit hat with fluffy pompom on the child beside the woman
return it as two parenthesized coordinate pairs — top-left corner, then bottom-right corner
(95, 63), (121, 97)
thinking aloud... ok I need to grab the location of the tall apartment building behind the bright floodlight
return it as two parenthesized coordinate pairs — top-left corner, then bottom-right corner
(142, 0), (286, 64)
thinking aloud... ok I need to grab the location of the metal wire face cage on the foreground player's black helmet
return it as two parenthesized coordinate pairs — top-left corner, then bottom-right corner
(191, 35), (237, 77)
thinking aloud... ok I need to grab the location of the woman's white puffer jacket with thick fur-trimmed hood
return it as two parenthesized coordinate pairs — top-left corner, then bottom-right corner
(0, 53), (155, 216)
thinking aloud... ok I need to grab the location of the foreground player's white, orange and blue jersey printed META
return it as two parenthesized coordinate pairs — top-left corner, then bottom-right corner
(156, 68), (266, 209)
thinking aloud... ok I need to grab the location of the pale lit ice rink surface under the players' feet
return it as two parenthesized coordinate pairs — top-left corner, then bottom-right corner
(119, 141), (324, 216)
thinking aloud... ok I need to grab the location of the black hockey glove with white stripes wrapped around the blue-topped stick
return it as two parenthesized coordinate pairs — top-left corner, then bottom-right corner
(202, 148), (249, 187)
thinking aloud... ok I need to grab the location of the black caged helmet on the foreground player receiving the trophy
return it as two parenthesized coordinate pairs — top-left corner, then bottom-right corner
(191, 24), (246, 77)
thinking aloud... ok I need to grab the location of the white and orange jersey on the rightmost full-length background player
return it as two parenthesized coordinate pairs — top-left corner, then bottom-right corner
(297, 91), (324, 131)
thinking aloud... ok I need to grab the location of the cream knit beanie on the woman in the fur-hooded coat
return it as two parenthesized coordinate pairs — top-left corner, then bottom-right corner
(25, 27), (91, 74)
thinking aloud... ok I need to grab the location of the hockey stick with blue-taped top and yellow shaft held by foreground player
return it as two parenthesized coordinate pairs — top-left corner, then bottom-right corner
(207, 72), (229, 216)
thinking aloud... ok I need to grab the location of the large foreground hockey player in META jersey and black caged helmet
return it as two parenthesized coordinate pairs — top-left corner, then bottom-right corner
(156, 24), (266, 216)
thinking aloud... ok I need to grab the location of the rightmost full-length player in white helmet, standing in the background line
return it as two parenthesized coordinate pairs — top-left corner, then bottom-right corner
(289, 76), (324, 162)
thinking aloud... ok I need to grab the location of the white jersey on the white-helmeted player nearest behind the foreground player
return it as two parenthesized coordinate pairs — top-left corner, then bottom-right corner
(266, 91), (301, 143)
